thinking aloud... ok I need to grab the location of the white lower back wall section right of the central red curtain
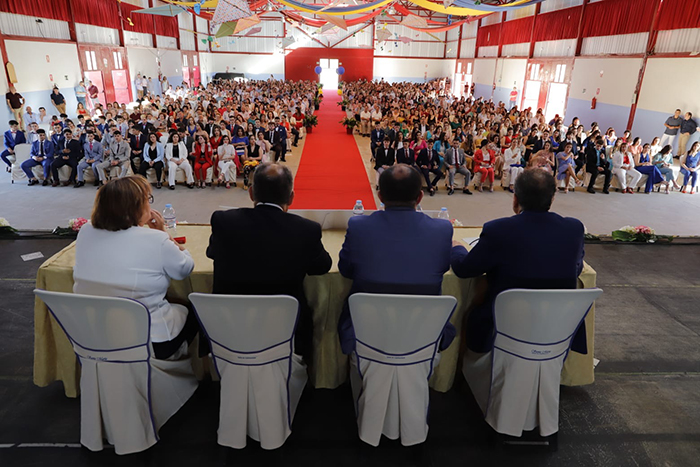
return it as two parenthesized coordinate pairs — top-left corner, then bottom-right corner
(374, 57), (455, 83)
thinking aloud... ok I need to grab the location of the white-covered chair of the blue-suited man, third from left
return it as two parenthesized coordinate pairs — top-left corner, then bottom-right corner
(349, 293), (457, 446)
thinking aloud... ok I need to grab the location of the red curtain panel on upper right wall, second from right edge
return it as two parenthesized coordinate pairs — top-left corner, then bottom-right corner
(583, 0), (656, 37)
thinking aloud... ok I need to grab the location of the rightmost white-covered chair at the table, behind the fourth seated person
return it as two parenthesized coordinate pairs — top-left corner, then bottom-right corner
(463, 289), (603, 436)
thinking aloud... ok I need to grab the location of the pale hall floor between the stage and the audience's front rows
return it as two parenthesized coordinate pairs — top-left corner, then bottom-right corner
(0, 134), (700, 236)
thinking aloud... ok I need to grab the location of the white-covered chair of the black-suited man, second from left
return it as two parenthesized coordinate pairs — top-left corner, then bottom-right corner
(190, 293), (307, 449)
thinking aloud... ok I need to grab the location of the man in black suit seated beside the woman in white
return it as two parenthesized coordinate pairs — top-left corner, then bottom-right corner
(207, 163), (331, 363)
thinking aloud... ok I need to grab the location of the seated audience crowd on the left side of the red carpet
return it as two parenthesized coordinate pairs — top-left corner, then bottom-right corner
(1, 79), (319, 189)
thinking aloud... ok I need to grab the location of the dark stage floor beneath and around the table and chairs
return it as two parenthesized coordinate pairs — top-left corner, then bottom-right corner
(0, 239), (700, 467)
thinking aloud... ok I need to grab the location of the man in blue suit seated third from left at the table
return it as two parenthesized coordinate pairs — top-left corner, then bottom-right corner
(338, 164), (455, 354)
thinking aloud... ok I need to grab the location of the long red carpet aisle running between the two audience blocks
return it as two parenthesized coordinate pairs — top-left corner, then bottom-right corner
(292, 89), (377, 209)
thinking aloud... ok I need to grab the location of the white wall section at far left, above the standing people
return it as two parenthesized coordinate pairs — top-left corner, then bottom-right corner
(5, 40), (81, 117)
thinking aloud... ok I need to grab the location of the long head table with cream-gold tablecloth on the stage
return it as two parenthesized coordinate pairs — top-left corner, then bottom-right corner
(34, 224), (596, 397)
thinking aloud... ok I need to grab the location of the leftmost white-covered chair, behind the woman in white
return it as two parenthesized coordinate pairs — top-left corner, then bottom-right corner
(34, 289), (198, 454)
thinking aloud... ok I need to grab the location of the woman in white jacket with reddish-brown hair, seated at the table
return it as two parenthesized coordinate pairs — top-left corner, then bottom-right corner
(73, 175), (198, 360)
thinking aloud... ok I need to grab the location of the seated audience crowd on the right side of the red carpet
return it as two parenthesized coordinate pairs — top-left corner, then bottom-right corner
(343, 80), (700, 195)
